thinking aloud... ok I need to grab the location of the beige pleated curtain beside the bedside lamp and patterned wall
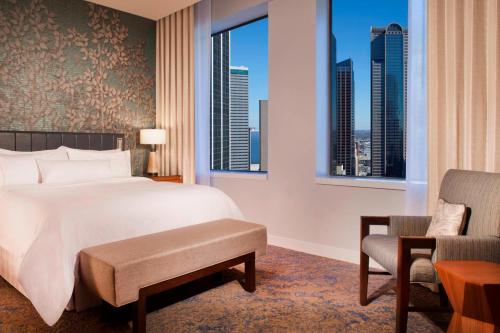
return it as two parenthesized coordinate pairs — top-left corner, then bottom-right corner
(156, 6), (195, 183)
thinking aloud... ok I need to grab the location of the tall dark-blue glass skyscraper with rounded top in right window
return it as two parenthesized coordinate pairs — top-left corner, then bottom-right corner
(371, 23), (408, 178)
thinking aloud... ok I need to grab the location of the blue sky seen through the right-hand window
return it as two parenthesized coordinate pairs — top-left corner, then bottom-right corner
(332, 0), (408, 130)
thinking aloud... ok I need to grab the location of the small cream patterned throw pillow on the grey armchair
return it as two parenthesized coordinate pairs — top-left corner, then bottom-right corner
(425, 199), (465, 237)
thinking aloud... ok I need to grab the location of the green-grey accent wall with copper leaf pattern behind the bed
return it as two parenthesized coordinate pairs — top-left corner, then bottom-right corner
(0, 0), (156, 175)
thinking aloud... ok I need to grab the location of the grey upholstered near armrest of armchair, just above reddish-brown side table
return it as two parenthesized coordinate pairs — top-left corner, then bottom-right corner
(432, 236), (500, 263)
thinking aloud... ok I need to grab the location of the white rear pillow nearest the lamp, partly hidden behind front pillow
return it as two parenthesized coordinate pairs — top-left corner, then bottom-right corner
(68, 150), (132, 177)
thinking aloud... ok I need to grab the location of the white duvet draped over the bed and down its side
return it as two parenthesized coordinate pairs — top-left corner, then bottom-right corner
(0, 178), (242, 325)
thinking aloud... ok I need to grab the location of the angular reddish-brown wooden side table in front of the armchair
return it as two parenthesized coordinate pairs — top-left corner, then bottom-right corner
(435, 261), (500, 333)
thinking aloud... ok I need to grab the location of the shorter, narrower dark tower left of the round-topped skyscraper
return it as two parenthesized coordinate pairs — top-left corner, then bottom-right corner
(334, 59), (356, 176)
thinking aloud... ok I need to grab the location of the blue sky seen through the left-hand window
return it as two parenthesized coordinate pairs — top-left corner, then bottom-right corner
(230, 18), (269, 130)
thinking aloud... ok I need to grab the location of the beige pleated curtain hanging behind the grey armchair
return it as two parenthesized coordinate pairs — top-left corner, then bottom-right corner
(427, 0), (500, 212)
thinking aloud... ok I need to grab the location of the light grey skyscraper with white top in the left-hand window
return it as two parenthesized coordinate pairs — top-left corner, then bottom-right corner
(229, 66), (250, 170)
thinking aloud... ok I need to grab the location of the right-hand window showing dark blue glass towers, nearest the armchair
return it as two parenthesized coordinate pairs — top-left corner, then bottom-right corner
(330, 0), (408, 178)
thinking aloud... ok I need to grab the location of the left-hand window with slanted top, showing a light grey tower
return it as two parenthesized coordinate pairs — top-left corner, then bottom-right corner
(210, 17), (268, 172)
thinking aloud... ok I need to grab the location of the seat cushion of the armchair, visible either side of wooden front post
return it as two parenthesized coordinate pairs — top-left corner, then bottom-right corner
(362, 235), (436, 283)
